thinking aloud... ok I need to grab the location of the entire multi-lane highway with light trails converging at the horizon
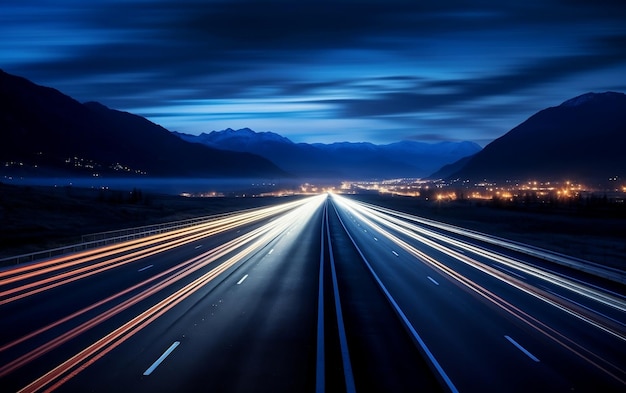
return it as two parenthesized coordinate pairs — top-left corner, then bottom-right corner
(0, 194), (626, 392)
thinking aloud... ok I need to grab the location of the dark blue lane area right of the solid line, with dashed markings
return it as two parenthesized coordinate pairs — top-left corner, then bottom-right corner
(333, 197), (625, 391)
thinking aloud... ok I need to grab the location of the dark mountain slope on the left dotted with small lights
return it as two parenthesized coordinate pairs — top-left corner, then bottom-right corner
(0, 70), (285, 177)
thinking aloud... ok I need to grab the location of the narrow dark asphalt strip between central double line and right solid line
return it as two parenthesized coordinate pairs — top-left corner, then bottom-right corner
(329, 202), (441, 392)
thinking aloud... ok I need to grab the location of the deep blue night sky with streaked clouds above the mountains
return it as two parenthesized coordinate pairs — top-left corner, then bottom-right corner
(0, 0), (626, 145)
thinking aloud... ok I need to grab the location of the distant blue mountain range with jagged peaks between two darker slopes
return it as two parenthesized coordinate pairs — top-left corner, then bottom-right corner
(175, 128), (480, 180)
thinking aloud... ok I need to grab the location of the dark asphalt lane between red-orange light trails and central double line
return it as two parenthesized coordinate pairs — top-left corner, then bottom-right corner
(61, 194), (321, 392)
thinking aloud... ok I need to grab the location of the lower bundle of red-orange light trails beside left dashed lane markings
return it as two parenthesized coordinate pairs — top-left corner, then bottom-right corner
(0, 197), (325, 391)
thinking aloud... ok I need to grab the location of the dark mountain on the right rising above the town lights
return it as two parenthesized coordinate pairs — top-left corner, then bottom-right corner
(432, 92), (626, 181)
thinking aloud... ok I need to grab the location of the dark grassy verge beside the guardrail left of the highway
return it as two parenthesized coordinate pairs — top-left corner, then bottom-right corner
(0, 183), (298, 258)
